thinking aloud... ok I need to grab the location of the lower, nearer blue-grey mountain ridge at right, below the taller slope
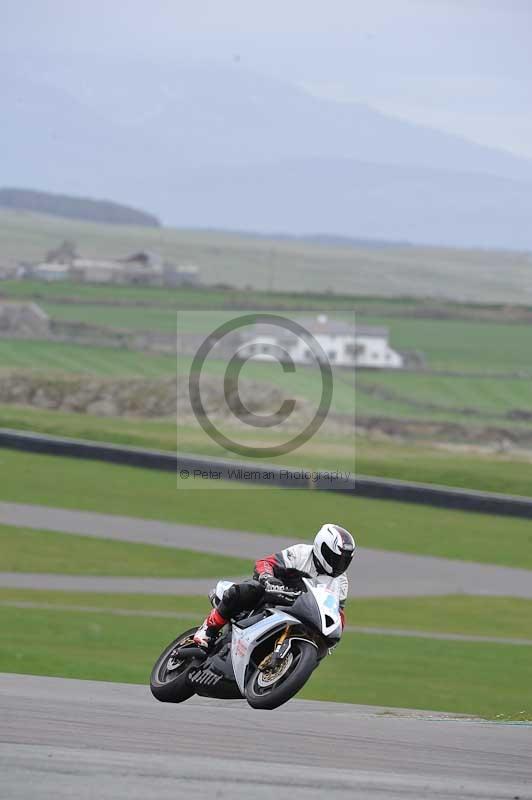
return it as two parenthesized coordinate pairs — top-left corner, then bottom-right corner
(148, 159), (532, 249)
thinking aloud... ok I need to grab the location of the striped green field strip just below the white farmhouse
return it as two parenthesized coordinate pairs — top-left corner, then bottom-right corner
(0, 339), (532, 438)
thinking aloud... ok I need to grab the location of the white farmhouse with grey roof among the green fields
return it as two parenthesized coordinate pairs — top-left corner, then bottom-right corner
(239, 314), (403, 369)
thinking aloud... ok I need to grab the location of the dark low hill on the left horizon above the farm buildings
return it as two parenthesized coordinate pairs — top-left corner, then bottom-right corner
(0, 188), (160, 228)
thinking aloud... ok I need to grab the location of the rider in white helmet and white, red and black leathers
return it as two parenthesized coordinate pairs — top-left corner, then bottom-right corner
(194, 522), (355, 650)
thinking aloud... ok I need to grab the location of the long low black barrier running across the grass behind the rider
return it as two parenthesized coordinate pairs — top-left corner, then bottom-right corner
(0, 428), (532, 519)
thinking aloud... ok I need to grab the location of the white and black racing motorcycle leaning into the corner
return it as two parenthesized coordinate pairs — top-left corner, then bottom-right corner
(150, 578), (342, 709)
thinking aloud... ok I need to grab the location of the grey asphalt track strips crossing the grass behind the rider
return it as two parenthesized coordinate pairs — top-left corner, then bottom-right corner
(0, 503), (532, 598)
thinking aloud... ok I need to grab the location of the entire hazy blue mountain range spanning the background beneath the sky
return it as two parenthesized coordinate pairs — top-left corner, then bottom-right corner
(4, 55), (532, 247)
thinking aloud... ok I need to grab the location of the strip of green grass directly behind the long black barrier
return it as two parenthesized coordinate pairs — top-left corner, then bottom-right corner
(0, 405), (532, 496)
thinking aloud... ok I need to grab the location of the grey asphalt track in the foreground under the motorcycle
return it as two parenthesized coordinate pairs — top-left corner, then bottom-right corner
(0, 675), (532, 800)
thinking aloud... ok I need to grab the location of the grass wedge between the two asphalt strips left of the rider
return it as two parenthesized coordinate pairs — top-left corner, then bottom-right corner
(0, 525), (249, 578)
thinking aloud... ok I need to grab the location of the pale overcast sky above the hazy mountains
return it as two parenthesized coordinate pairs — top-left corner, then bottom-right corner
(4, 0), (532, 158)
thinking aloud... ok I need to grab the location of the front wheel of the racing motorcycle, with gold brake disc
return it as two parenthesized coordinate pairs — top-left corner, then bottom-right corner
(245, 639), (318, 709)
